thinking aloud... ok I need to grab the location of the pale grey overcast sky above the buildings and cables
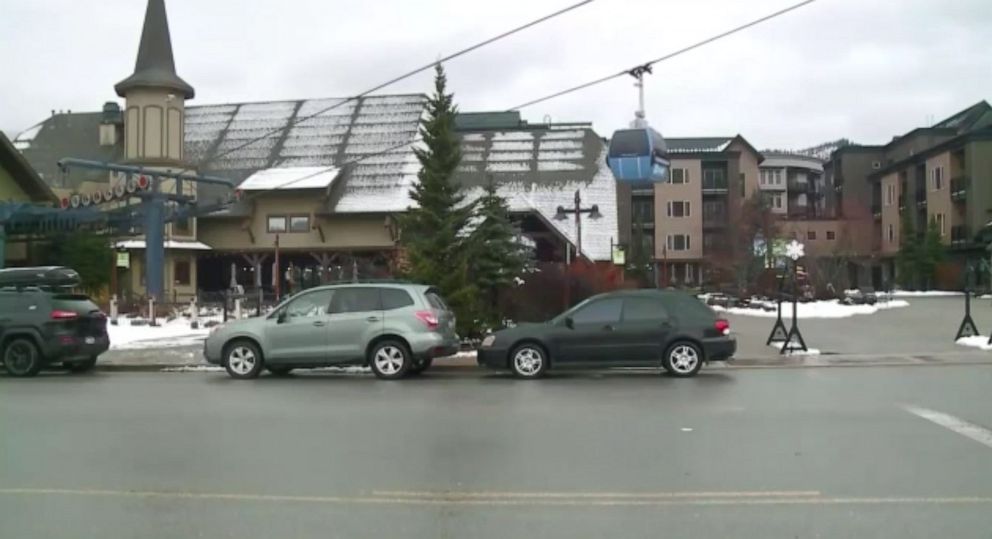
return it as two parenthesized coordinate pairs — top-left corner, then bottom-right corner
(0, 0), (992, 148)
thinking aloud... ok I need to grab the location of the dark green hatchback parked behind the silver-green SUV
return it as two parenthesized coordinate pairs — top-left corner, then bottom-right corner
(478, 290), (737, 378)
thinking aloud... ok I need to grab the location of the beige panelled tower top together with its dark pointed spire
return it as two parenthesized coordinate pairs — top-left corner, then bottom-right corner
(114, 0), (195, 166)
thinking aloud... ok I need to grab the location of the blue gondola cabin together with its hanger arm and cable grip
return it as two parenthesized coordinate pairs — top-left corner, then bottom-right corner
(606, 64), (671, 187)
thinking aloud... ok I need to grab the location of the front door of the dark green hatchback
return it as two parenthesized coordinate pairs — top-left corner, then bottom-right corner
(557, 298), (623, 363)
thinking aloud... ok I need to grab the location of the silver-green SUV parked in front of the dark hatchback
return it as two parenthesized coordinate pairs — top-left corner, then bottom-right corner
(203, 283), (458, 379)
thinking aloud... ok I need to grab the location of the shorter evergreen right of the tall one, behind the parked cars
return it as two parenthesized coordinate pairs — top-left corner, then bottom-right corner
(469, 178), (530, 327)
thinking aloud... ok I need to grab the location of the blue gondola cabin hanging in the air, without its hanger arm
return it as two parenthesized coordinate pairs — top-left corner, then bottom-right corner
(606, 127), (669, 184)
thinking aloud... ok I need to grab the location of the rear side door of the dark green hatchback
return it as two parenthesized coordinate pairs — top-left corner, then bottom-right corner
(615, 297), (672, 364)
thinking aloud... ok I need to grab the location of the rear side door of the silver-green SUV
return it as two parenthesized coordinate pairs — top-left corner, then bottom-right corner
(327, 286), (384, 363)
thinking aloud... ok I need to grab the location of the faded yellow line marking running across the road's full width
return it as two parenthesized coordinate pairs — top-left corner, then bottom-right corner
(0, 488), (992, 507)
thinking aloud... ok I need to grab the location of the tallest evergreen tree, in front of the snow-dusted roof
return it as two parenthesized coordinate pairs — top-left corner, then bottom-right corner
(399, 64), (476, 334)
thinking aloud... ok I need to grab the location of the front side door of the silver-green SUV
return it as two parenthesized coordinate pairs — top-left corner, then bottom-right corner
(265, 289), (333, 364)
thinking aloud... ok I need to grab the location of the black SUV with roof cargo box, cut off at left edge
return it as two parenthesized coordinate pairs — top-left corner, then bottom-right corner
(0, 266), (110, 376)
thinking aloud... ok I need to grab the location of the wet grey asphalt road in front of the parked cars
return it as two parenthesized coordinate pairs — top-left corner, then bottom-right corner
(0, 365), (992, 539)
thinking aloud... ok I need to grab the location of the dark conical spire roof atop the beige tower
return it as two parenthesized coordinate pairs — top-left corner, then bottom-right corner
(114, 0), (194, 99)
